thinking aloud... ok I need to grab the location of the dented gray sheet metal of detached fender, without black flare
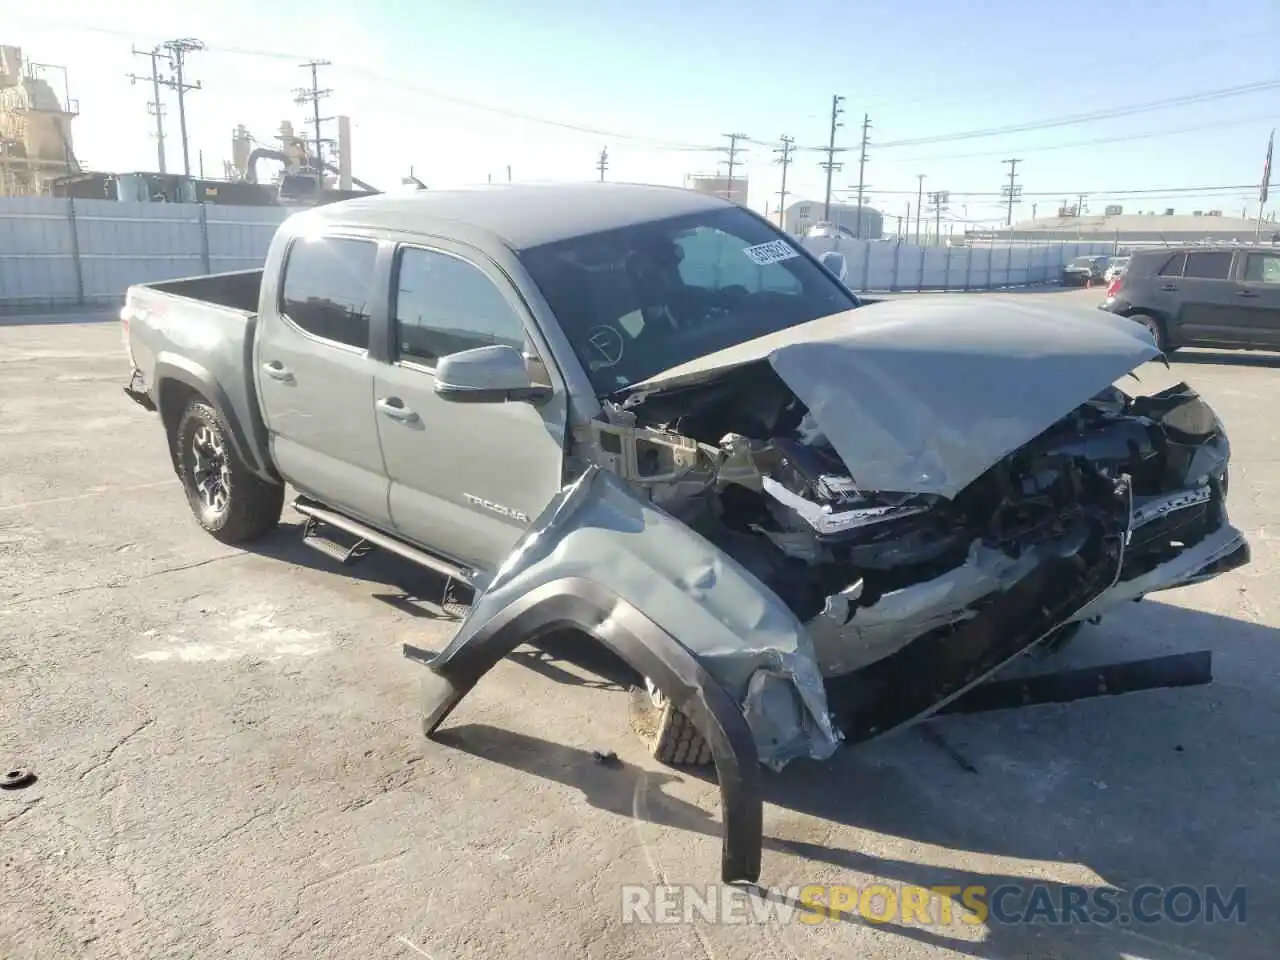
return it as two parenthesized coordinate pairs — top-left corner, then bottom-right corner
(442, 467), (838, 768)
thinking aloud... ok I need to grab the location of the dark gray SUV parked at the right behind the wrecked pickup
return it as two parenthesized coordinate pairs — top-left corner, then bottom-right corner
(1100, 246), (1280, 353)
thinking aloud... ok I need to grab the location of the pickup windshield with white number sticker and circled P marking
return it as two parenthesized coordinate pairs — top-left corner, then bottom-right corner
(520, 207), (858, 397)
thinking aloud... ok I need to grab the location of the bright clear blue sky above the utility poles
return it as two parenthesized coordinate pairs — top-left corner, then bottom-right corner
(0, 0), (1280, 226)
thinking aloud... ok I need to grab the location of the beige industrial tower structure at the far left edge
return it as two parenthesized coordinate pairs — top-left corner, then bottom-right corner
(0, 46), (79, 197)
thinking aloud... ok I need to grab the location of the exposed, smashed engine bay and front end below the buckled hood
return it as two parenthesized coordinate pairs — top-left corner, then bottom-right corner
(584, 364), (1247, 678)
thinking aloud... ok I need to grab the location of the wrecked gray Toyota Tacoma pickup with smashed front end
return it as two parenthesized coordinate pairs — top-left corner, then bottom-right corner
(122, 184), (1248, 879)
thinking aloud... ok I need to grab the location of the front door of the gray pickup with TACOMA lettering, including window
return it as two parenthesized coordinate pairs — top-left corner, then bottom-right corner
(374, 242), (567, 570)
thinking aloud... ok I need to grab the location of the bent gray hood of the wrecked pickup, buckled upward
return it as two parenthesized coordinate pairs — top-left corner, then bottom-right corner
(629, 293), (1160, 498)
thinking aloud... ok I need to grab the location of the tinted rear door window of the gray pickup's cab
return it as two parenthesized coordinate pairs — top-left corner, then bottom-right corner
(280, 237), (378, 349)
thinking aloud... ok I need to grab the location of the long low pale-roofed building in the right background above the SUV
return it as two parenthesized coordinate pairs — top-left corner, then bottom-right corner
(965, 206), (1280, 244)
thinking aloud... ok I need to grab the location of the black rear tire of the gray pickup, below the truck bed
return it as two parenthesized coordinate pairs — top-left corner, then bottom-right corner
(170, 398), (284, 544)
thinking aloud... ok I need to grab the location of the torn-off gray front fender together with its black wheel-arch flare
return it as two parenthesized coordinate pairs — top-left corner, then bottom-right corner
(406, 467), (838, 879)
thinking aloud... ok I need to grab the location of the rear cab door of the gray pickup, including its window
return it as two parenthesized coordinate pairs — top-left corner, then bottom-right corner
(255, 237), (390, 527)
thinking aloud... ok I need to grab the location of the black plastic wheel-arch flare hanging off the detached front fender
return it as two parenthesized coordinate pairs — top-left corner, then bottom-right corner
(406, 577), (763, 883)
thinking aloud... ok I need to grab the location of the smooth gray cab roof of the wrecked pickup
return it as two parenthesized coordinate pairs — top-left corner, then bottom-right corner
(291, 183), (732, 250)
